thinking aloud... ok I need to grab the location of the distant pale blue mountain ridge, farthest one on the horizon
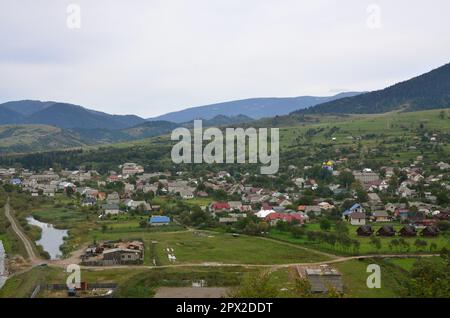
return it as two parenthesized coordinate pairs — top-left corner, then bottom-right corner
(148, 92), (361, 123)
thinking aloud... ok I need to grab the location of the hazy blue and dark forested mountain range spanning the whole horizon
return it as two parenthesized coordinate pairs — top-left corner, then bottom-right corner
(0, 60), (450, 153)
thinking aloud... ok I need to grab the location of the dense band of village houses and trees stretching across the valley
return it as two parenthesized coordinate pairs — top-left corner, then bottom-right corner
(0, 157), (450, 243)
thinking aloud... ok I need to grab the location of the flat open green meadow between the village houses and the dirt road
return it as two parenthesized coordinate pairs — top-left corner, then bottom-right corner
(91, 231), (325, 265)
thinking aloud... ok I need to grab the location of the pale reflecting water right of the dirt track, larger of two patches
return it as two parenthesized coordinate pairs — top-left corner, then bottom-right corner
(27, 216), (68, 260)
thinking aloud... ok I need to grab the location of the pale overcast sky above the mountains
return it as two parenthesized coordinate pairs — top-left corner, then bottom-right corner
(0, 0), (450, 118)
